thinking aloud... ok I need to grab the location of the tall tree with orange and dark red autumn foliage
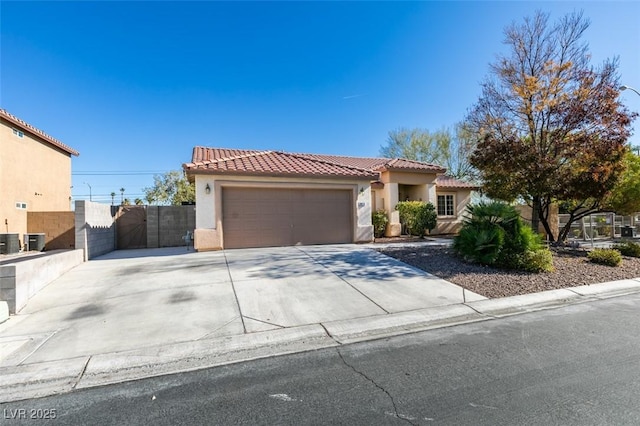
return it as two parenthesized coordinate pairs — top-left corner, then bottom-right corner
(465, 12), (637, 240)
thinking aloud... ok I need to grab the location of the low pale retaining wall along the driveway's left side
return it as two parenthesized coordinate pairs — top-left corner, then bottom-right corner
(0, 250), (84, 314)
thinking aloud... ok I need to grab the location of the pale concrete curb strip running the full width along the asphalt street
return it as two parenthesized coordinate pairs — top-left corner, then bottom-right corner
(0, 278), (640, 402)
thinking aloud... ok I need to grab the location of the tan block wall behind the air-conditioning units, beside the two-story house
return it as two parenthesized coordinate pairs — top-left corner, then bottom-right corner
(27, 212), (76, 250)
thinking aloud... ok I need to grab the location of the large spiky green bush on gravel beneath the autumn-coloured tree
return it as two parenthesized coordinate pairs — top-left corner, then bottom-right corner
(453, 202), (553, 271)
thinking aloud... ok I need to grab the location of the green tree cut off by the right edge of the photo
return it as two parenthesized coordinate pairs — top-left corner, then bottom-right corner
(607, 152), (640, 215)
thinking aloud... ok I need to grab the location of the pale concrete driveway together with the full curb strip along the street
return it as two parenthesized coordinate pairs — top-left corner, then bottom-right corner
(0, 245), (640, 402)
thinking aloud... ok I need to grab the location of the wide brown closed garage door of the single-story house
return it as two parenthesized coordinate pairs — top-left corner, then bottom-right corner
(222, 188), (353, 248)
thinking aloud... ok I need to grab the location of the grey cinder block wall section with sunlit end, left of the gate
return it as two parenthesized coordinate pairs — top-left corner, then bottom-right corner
(75, 200), (116, 260)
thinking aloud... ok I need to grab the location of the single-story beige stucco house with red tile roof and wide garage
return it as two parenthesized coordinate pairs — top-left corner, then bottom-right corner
(183, 147), (477, 250)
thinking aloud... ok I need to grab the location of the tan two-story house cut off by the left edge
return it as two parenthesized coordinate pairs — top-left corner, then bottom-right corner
(0, 109), (78, 245)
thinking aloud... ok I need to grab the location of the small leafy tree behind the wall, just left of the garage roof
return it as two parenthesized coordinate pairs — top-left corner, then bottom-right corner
(142, 170), (196, 206)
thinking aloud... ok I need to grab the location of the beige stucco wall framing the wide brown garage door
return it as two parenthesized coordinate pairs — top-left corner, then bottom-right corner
(194, 174), (373, 251)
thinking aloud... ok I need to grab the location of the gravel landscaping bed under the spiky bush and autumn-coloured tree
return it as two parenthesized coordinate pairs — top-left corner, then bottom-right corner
(377, 246), (640, 298)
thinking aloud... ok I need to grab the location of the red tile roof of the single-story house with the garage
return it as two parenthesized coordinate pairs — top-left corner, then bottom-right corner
(183, 146), (446, 179)
